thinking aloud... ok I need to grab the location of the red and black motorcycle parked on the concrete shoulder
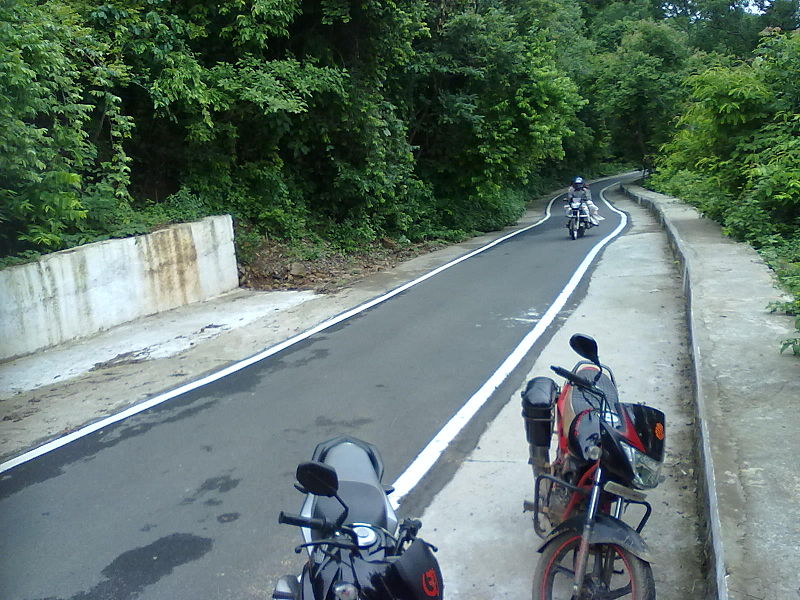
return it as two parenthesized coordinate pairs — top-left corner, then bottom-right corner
(522, 334), (664, 600)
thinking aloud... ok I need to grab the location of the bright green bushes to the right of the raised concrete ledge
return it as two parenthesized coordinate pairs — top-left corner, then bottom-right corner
(653, 30), (800, 354)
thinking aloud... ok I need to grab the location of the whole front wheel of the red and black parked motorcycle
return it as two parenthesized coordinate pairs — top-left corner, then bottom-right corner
(532, 531), (656, 600)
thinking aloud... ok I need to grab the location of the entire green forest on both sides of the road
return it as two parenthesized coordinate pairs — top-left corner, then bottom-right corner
(0, 0), (800, 351)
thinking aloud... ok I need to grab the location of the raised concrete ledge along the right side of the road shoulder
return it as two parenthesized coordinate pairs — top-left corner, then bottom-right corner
(620, 184), (800, 600)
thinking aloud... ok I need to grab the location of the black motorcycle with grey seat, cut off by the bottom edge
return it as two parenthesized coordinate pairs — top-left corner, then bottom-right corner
(272, 436), (444, 600)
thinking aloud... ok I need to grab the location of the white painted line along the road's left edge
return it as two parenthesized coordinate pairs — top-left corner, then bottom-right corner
(0, 192), (564, 473)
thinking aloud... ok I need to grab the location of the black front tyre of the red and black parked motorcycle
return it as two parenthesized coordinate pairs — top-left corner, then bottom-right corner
(531, 531), (656, 600)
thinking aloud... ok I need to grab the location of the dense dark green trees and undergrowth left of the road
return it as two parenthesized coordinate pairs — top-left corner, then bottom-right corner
(0, 0), (584, 254)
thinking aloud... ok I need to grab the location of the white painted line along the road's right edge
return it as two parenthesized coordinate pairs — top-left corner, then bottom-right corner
(390, 183), (628, 508)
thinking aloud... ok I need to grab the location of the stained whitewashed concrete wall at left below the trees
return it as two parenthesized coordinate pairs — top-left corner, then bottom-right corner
(0, 215), (239, 360)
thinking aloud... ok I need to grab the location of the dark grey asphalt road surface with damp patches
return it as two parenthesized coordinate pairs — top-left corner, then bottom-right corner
(0, 178), (632, 600)
